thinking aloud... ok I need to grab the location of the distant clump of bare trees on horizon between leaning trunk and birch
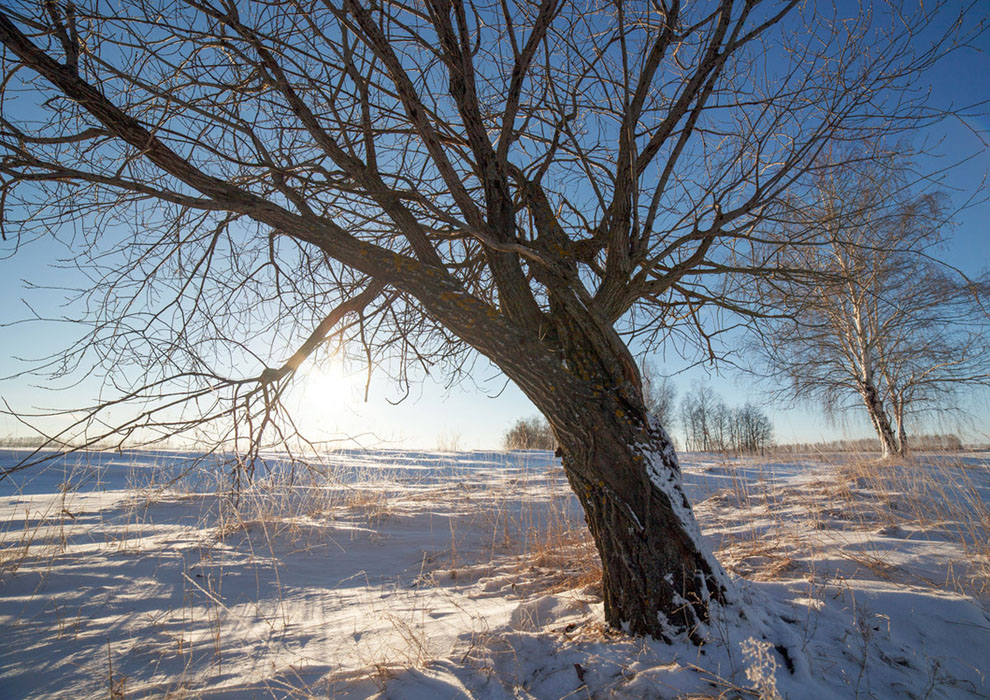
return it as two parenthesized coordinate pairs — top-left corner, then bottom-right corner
(681, 385), (773, 454)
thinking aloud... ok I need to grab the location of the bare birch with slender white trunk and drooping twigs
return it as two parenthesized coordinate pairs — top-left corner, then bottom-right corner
(760, 147), (990, 457)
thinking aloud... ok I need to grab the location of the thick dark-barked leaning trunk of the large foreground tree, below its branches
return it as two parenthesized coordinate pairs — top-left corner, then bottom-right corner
(504, 302), (730, 641)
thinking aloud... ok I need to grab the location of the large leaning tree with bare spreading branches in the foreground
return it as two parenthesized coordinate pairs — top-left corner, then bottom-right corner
(0, 0), (978, 640)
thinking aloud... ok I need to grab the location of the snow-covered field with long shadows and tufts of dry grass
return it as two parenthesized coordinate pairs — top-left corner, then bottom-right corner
(0, 451), (990, 700)
